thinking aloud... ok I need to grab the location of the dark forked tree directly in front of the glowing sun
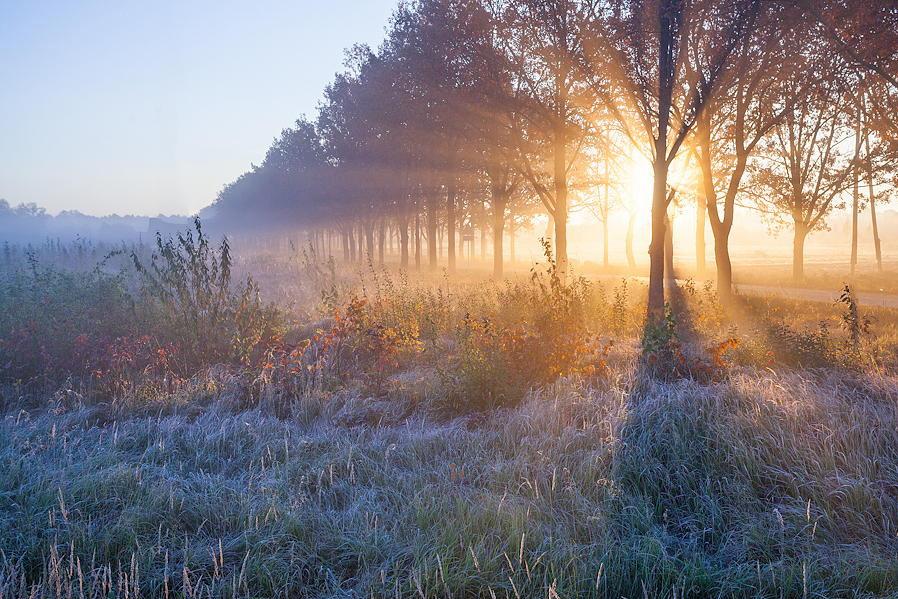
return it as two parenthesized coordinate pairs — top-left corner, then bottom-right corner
(584, 0), (760, 321)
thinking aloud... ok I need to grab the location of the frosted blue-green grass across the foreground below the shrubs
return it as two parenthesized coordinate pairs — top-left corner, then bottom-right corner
(0, 371), (898, 597)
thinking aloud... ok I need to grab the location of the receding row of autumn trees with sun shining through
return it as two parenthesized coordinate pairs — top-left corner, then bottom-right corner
(215, 0), (898, 316)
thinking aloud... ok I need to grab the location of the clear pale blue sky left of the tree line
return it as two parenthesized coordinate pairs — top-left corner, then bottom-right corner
(0, 0), (396, 215)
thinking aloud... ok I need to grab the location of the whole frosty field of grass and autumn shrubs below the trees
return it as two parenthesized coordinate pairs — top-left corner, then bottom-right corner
(0, 231), (898, 598)
